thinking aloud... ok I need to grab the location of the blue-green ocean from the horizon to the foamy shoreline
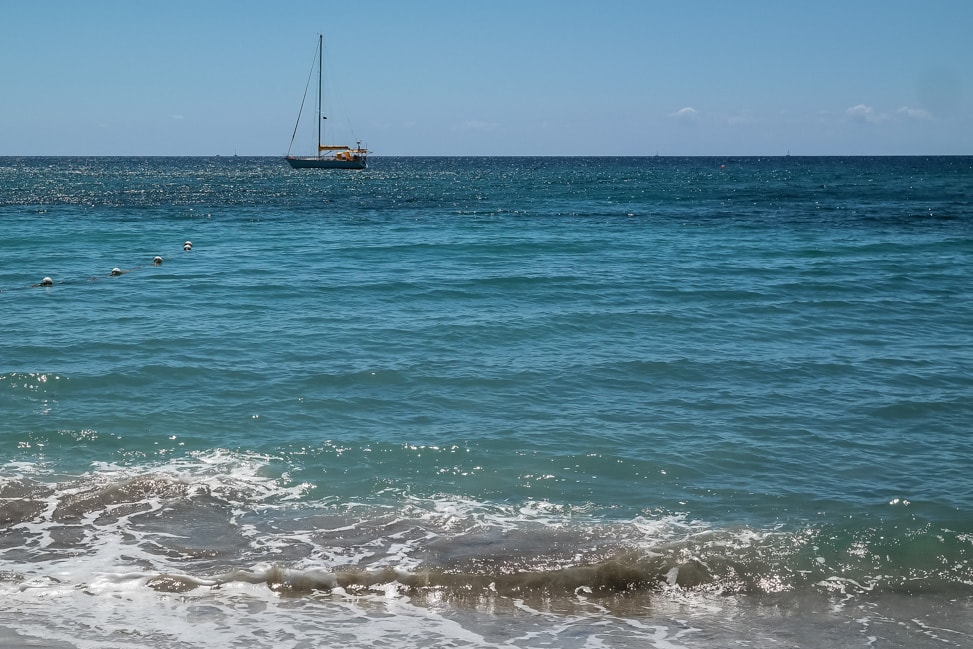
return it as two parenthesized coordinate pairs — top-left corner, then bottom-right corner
(0, 156), (973, 649)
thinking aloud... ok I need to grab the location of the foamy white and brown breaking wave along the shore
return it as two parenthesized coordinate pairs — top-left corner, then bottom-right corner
(0, 450), (973, 612)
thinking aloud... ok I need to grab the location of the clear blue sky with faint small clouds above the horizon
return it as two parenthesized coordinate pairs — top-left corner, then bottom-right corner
(0, 0), (973, 156)
